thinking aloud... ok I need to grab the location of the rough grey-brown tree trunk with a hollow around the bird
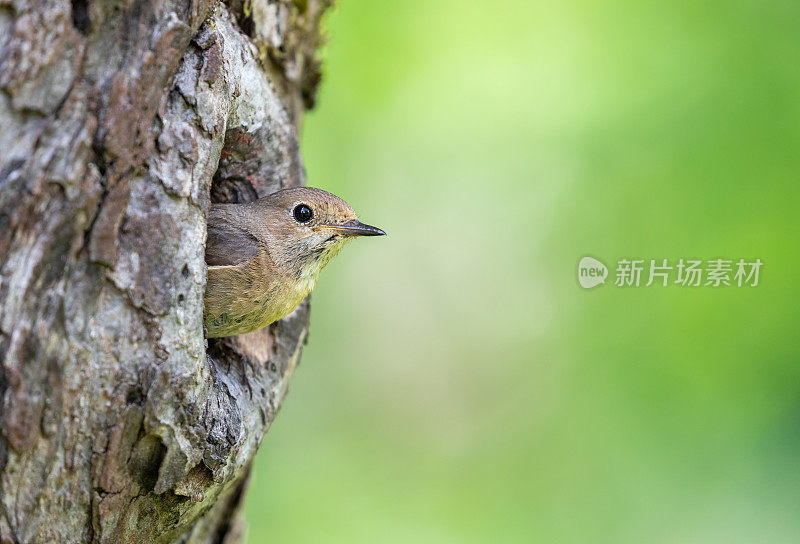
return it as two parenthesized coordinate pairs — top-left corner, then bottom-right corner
(0, 0), (327, 543)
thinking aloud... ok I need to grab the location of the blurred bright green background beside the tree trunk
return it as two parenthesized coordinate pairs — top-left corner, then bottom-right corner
(246, 0), (800, 544)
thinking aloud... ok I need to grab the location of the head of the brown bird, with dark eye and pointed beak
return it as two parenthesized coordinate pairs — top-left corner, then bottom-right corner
(262, 187), (386, 291)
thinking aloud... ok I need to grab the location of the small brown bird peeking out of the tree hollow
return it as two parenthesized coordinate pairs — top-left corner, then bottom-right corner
(203, 187), (386, 338)
